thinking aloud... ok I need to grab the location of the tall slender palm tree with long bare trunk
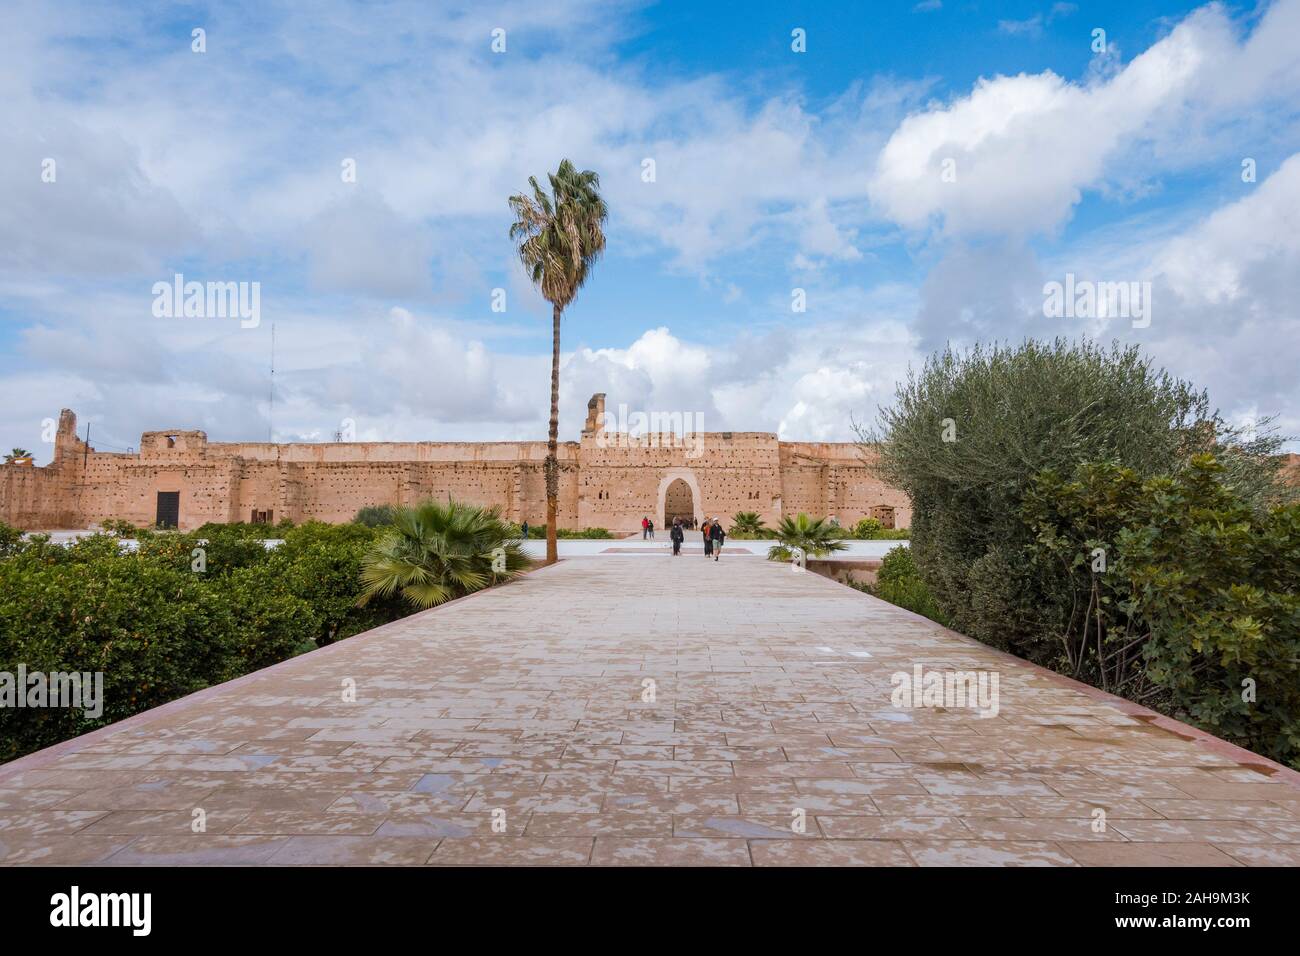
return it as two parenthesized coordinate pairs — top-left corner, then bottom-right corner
(510, 160), (608, 564)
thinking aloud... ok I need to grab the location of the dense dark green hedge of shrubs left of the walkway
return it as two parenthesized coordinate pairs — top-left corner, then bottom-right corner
(0, 523), (410, 761)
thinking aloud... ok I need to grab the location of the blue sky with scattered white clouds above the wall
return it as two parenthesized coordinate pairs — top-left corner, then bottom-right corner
(0, 0), (1300, 463)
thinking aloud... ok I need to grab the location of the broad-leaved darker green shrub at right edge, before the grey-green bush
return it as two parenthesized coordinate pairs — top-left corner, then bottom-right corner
(1024, 455), (1300, 766)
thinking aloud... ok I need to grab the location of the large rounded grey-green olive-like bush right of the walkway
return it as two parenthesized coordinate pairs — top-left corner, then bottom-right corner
(862, 339), (1281, 665)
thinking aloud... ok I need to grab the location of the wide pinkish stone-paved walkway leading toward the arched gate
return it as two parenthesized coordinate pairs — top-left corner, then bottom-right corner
(0, 555), (1300, 866)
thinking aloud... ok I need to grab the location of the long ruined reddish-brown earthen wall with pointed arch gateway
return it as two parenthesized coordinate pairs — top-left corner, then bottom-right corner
(0, 395), (911, 533)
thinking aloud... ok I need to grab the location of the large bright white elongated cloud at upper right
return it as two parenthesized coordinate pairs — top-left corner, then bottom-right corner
(870, 0), (1300, 237)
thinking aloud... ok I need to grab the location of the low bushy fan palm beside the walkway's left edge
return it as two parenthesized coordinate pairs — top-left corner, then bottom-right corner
(358, 501), (528, 609)
